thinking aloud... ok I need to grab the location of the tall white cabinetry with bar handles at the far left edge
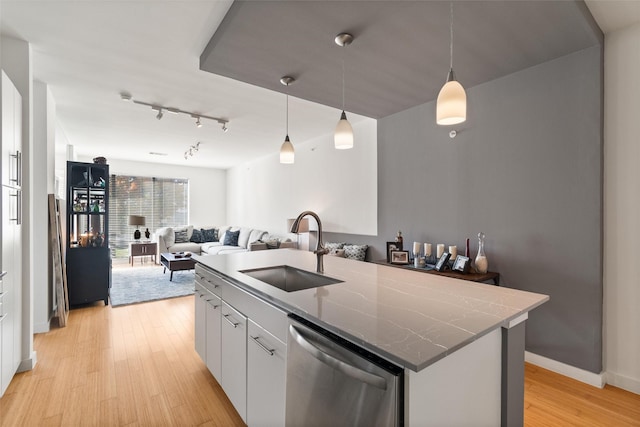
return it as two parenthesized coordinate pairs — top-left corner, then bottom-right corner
(0, 71), (22, 396)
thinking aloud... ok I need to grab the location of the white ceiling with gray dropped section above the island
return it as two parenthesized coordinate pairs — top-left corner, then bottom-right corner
(0, 0), (640, 168)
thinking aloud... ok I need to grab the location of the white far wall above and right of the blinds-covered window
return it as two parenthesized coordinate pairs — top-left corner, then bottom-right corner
(72, 157), (227, 232)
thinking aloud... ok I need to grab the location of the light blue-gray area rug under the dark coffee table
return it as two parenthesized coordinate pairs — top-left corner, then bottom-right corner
(111, 266), (195, 307)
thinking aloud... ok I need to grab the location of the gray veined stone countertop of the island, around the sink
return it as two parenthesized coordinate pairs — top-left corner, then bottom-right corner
(194, 249), (549, 371)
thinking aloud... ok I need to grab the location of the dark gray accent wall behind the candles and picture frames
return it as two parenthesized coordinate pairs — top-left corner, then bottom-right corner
(325, 45), (603, 373)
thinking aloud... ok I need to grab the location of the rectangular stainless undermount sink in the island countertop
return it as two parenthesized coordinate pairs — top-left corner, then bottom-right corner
(240, 265), (342, 292)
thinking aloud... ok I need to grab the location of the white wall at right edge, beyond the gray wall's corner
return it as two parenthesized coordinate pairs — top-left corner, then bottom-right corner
(604, 20), (640, 393)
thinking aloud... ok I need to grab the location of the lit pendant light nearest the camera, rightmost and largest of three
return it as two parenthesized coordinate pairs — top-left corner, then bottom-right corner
(436, 2), (467, 125)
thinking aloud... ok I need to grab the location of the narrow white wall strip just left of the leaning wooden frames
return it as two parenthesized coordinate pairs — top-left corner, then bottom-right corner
(31, 81), (55, 333)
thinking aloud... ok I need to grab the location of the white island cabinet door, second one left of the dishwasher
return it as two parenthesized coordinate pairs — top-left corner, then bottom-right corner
(220, 301), (247, 422)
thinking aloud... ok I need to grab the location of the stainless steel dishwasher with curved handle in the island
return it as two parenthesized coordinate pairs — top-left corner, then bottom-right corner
(285, 314), (404, 427)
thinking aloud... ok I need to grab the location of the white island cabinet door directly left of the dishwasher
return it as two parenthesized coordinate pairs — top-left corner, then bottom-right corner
(247, 320), (287, 427)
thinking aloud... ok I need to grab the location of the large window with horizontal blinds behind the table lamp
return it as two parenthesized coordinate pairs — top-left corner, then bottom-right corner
(109, 175), (189, 257)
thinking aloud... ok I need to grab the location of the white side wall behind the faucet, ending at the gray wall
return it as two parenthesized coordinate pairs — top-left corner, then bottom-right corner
(227, 119), (378, 236)
